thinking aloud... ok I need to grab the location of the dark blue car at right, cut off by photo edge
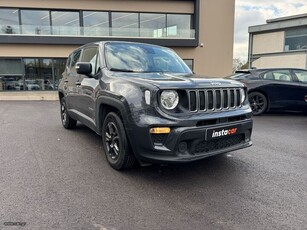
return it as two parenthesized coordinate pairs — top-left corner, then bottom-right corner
(227, 68), (307, 115)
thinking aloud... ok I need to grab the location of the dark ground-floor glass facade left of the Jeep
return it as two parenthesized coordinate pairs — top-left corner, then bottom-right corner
(0, 58), (66, 91)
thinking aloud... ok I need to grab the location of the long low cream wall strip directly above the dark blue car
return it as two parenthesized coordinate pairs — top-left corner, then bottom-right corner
(253, 53), (307, 69)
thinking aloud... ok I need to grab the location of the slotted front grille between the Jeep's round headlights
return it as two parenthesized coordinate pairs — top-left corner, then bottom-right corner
(188, 88), (242, 112)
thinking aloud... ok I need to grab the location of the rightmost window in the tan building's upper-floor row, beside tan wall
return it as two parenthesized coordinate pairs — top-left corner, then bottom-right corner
(167, 14), (192, 38)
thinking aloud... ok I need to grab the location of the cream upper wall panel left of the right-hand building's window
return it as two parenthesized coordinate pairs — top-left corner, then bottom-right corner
(253, 31), (285, 55)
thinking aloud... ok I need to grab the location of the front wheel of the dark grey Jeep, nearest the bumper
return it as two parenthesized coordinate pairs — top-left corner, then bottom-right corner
(102, 112), (135, 170)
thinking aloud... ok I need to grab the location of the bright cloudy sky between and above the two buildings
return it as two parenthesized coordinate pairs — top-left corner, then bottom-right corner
(234, 0), (307, 60)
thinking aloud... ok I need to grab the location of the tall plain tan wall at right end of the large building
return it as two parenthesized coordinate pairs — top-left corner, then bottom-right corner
(200, 0), (235, 77)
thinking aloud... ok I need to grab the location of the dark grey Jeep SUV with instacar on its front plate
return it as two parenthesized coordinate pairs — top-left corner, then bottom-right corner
(58, 41), (252, 170)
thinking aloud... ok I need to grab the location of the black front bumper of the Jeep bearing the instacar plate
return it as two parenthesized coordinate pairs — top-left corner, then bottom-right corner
(129, 118), (253, 163)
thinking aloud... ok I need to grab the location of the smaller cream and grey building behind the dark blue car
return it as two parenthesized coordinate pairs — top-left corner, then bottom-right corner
(248, 14), (307, 69)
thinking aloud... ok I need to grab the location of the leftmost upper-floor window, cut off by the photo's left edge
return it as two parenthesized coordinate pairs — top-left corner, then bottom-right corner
(0, 9), (20, 34)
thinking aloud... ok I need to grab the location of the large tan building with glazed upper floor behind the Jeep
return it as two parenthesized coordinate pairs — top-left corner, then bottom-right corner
(0, 0), (235, 100)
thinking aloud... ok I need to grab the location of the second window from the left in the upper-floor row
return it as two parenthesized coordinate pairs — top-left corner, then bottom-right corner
(20, 10), (50, 34)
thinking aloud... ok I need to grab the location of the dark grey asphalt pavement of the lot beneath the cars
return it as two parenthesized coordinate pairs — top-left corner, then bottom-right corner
(0, 101), (307, 230)
